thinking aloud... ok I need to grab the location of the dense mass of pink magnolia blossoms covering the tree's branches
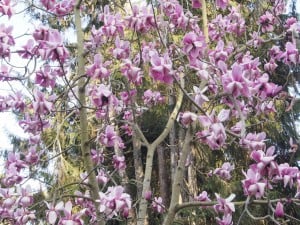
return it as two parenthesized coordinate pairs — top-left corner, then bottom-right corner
(0, 0), (300, 225)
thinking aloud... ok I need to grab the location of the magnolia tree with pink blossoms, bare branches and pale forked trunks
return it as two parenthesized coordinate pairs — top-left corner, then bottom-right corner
(0, 0), (300, 225)
